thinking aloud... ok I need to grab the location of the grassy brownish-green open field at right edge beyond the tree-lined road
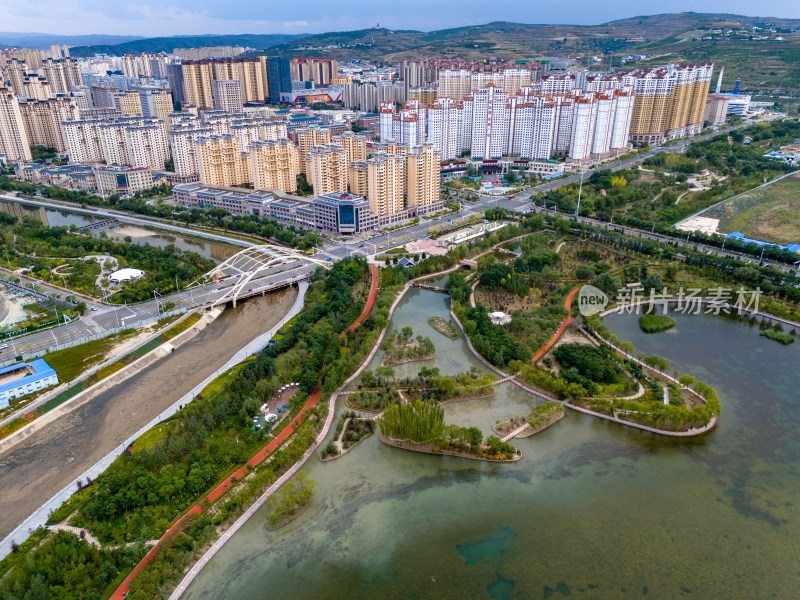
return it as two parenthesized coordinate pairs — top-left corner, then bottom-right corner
(707, 174), (800, 244)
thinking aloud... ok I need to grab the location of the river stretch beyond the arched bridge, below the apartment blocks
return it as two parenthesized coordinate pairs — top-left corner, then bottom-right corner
(0, 200), (241, 262)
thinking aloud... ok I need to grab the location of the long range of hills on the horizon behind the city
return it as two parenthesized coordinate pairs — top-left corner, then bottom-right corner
(59, 12), (800, 94)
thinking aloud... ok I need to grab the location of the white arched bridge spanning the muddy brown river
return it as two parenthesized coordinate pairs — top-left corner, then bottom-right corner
(205, 244), (331, 306)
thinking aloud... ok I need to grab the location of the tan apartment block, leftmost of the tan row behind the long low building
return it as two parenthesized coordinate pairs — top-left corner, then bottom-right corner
(194, 135), (253, 187)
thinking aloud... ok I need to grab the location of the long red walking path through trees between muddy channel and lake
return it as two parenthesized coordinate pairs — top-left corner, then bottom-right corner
(110, 265), (378, 600)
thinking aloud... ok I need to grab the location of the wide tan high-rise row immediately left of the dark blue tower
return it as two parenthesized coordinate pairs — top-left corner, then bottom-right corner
(182, 56), (269, 109)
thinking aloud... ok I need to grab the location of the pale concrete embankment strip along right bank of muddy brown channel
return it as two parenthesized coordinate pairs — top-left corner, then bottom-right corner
(0, 281), (308, 558)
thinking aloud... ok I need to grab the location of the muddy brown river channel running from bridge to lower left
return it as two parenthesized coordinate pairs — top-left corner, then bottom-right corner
(0, 289), (297, 538)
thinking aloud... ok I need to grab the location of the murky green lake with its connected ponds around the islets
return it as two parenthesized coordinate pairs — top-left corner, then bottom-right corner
(184, 291), (800, 600)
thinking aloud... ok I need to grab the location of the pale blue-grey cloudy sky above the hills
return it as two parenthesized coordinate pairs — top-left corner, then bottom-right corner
(0, 0), (800, 37)
